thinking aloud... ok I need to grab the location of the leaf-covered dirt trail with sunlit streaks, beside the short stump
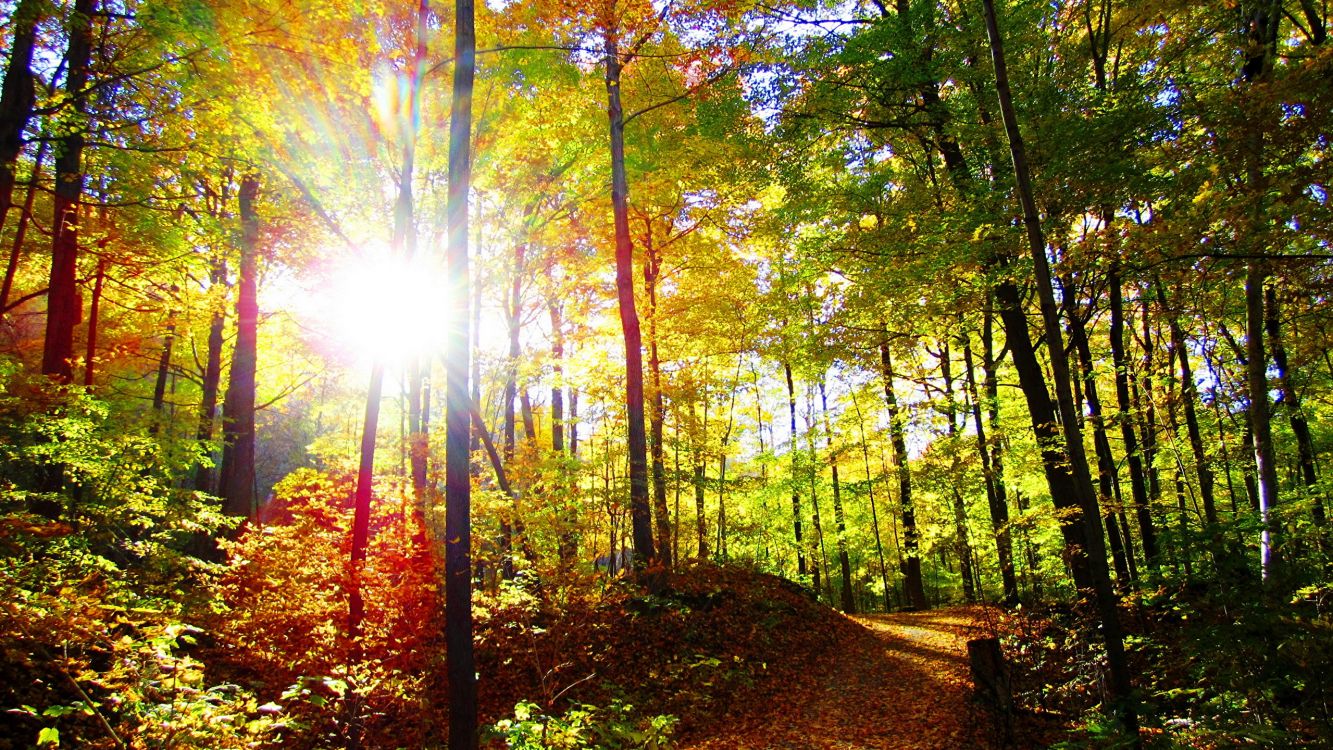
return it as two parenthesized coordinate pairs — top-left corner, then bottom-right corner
(684, 607), (998, 750)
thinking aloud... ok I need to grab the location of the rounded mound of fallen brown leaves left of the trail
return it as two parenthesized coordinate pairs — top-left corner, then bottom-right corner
(477, 565), (873, 738)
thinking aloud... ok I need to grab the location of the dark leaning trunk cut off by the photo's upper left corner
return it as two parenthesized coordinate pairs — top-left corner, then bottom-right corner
(0, 0), (40, 237)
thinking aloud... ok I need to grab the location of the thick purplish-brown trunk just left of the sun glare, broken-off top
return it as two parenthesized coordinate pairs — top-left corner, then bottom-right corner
(217, 175), (259, 517)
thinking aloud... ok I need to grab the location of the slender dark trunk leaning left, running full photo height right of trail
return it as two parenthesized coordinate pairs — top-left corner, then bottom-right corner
(982, 0), (1138, 735)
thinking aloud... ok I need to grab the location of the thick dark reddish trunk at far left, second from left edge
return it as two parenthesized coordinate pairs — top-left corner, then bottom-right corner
(41, 0), (97, 382)
